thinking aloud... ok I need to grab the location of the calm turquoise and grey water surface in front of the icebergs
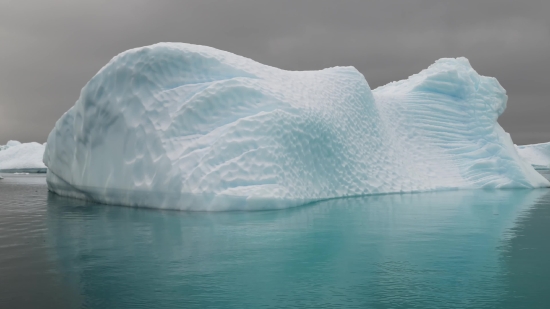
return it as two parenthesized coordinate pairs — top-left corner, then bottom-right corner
(0, 174), (550, 309)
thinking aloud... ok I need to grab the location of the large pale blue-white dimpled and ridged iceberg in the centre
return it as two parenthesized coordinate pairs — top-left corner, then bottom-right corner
(44, 43), (549, 210)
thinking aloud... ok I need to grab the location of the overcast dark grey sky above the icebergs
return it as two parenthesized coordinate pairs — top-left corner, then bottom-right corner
(0, 0), (550, 144)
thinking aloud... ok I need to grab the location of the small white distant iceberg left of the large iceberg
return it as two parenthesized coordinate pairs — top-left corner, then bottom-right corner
(0, 141), (47, 173)
